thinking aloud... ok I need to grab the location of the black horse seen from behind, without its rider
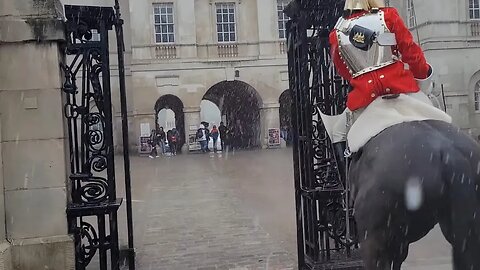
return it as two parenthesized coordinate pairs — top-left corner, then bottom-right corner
(348, 120), (480, 270)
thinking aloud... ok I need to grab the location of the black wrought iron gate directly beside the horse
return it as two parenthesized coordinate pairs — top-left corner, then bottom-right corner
(285, 0), (362, 270)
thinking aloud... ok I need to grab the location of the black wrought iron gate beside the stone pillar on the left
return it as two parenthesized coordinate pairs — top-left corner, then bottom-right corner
(62, 1), (135, 270)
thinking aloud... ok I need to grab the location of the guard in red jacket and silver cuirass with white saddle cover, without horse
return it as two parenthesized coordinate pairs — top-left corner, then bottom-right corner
(322, 0), (451, 158)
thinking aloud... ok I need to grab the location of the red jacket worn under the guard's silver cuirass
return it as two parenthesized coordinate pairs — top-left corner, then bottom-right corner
(330, 8), (429, 111)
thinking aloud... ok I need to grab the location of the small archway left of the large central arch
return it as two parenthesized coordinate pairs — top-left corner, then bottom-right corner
(155, 95), (185, 150)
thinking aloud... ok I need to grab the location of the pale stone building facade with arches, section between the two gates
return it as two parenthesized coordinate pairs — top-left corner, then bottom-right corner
(130, 0), (288, 150)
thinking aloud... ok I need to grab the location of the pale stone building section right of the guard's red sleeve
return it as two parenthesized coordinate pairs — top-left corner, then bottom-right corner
(390, 0), (480, 138)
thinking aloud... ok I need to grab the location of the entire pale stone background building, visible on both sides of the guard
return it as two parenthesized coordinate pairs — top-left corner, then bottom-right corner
(74, 0), (480, 151)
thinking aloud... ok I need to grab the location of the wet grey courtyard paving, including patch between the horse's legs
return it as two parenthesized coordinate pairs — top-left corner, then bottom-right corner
(117, 149), (452, 270)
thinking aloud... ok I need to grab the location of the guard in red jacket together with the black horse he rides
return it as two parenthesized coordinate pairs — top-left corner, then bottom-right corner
(314, 0), (480, 270)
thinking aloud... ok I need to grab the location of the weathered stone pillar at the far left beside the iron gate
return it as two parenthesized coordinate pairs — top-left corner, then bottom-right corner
(0, 0), (74, 270)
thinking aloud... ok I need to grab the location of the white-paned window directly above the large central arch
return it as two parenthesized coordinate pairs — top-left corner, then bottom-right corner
(216, 3), (237, 42)
